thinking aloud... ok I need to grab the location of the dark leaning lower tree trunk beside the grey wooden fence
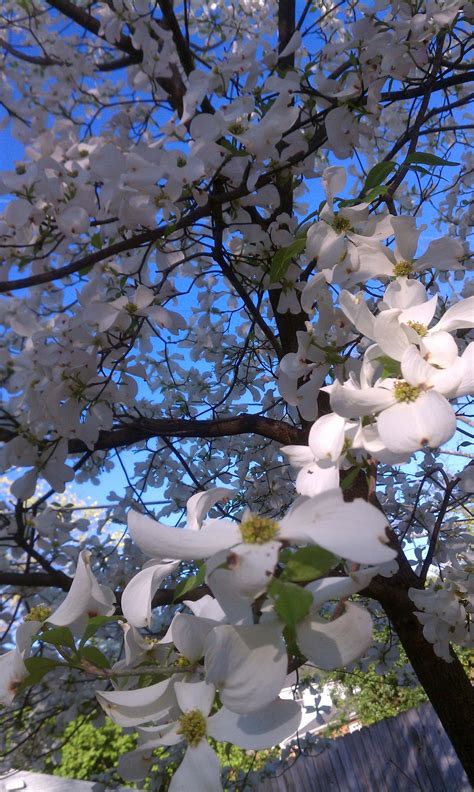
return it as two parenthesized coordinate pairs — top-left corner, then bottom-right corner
(364, 561), (474, 786)
